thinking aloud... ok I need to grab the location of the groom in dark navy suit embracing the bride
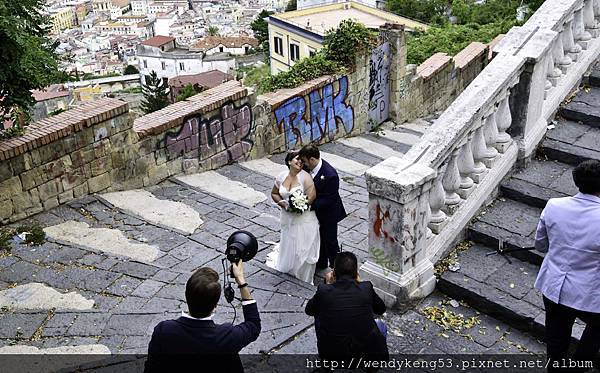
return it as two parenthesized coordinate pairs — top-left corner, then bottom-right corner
(298, 145), (346, 269)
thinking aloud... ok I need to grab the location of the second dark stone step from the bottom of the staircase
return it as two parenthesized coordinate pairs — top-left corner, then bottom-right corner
(467, 198), (544, 265)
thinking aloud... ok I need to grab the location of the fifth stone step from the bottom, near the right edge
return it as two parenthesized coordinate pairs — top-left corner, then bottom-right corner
(560, 87), (600, 127)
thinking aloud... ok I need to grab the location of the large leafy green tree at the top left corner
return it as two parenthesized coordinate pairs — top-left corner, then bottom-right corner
(0, 0), (64, 125)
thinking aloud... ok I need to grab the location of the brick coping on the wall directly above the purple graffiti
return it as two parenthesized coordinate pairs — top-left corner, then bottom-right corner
(133, 80), (248, 137)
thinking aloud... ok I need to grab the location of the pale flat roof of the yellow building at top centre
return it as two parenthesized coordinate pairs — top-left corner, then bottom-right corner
(269, 1), (428, 36)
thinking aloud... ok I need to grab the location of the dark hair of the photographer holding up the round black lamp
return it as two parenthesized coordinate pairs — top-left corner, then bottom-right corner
(185, 267), (221, 318)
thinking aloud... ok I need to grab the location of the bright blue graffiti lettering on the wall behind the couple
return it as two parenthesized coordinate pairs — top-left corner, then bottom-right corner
(274, 76), (355, 149)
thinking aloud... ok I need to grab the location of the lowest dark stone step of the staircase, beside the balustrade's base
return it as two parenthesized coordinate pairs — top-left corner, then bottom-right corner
(437, 245), (583, 341)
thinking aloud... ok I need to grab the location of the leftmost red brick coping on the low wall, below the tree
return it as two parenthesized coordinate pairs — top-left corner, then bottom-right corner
(0, 98), (129, 161)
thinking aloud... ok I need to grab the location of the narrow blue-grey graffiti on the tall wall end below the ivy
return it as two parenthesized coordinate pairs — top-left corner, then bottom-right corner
(369, 42), (392, 125)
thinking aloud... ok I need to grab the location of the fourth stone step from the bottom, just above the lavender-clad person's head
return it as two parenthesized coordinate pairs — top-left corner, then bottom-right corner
(540, 120), (600, 165)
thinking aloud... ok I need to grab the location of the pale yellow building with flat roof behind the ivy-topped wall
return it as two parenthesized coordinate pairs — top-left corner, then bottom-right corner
(267, 1), (428, 75)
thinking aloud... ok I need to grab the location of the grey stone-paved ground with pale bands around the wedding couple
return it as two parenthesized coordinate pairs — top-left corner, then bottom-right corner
(0, 115), (541, 371)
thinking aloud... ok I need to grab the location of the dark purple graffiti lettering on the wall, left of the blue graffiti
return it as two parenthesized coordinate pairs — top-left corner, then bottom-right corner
(165, 103), (252, 166)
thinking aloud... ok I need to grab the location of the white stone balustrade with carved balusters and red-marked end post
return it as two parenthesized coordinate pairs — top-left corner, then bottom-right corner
(361, 0), (600, 304)
